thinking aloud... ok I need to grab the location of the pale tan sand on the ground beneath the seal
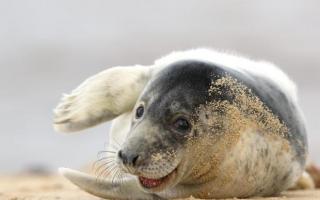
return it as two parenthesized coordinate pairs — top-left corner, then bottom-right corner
(0, 175), (320, 200)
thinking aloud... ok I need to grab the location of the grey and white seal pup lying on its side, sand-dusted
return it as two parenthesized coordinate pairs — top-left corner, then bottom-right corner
(54, 49), (307, 199)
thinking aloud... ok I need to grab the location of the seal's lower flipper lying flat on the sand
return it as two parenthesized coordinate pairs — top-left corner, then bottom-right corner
(59, 168), (160, 200)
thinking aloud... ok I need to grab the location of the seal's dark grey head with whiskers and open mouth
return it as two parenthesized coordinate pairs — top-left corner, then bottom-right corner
(118, 61), (224, 192)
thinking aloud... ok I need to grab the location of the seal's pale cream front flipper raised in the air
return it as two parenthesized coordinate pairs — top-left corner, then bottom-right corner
(54, 66), (150, 132)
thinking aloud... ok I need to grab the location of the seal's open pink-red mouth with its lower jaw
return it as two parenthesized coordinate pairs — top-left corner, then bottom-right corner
(138, 168), (178, 192)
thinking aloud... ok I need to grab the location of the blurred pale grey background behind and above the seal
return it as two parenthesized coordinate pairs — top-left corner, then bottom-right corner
(0, 0), (320, 173)
